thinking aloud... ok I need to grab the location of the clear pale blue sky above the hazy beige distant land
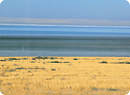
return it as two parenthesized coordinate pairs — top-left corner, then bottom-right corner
(0, 0), (130, 24)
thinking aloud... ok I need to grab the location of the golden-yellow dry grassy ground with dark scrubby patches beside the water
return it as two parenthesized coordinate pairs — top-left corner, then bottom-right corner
(0, 57), (130, 95)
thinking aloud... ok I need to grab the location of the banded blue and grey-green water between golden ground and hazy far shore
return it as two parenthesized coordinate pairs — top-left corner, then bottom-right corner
(0, 25), (130, 56)
